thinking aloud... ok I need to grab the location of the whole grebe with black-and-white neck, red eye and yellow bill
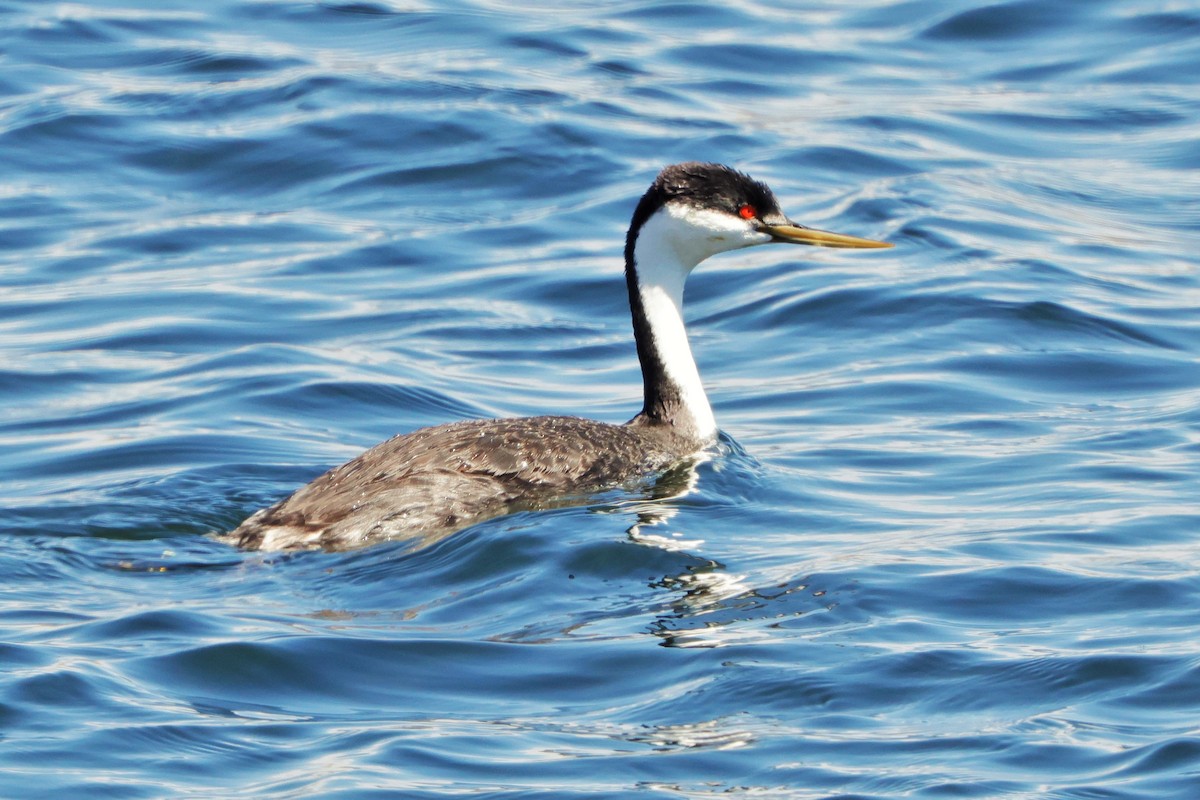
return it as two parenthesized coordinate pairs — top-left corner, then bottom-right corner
(226, 162), (892, 551)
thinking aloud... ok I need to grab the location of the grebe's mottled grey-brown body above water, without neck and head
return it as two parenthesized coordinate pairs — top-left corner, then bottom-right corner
(236, 416), (697, 549)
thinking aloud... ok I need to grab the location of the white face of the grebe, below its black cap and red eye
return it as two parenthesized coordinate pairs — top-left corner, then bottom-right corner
(638, 203), (772, 269)
